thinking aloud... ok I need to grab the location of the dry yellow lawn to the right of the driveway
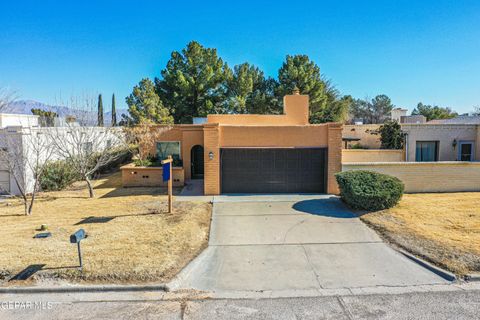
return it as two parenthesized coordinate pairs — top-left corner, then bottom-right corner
(361, 192), (480, 275)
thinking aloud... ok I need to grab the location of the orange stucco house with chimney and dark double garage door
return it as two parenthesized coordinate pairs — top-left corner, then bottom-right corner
(124, 94), (342, 195)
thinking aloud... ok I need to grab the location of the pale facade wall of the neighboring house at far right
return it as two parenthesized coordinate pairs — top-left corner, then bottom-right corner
(402, 124), (480, 161)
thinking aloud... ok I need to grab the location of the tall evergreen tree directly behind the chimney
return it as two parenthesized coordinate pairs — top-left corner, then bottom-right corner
(277, 55), (348, 123)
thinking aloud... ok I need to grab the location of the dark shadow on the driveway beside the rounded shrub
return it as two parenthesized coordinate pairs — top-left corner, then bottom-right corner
(292, 197), (367, 219)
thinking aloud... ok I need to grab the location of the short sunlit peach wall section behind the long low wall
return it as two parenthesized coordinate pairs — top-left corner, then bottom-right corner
(342, 149), (405, 162)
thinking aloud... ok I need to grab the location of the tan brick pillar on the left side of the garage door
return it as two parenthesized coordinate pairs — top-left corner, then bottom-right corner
(203, 124), (220, 195)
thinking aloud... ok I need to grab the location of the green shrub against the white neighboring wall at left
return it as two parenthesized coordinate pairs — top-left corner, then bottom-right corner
(40, 160), (81, 191)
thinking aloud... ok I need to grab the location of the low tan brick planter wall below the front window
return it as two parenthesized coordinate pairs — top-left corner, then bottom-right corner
(120, 165), (185, 187)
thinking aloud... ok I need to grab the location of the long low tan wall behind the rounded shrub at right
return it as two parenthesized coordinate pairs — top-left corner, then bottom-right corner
(342, 161), (480, 193)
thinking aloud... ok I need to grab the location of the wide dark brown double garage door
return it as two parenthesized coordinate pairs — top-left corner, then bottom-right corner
(220, 148), (327, 193)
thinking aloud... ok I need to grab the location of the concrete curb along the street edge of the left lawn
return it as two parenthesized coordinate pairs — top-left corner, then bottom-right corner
(0, 284), (169, 293)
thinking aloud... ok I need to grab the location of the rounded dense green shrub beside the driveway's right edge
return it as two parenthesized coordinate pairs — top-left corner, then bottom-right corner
(335, 170), (405, 211)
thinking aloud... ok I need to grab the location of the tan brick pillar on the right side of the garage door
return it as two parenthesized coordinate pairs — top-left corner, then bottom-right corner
(327, 123), (342, 194)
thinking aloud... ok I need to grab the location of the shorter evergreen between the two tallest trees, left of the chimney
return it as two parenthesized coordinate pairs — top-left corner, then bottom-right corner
(226, 62), (281, 114)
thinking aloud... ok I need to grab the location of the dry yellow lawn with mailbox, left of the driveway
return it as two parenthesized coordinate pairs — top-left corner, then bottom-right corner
(0, 173), (211, 284)
